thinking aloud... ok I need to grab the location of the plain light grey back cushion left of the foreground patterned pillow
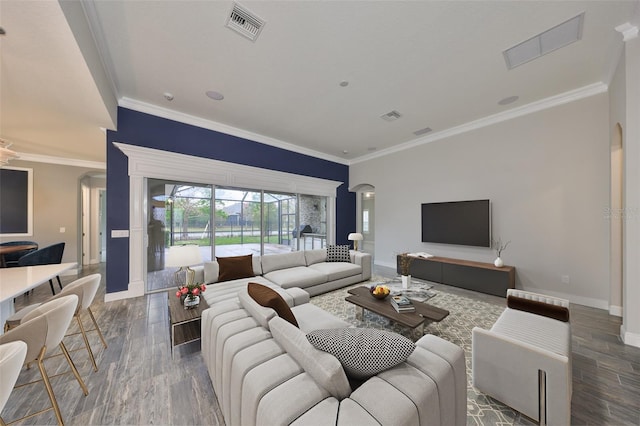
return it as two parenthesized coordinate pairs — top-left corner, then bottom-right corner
(269, 317), (351, 400)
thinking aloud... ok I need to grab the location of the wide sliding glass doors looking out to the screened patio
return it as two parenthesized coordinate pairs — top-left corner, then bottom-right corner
(147, 178), (327, 292)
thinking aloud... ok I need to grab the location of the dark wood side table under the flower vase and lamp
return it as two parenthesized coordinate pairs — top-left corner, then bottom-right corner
(167, 292), (209, 358)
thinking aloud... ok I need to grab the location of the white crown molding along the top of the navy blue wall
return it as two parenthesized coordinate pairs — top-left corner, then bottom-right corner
(118, 97), (349, 165)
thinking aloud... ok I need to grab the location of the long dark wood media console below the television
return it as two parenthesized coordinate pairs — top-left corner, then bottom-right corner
(396, 256), (516, 297)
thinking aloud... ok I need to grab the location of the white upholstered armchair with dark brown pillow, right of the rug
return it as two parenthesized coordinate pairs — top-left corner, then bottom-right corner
(472, 289), (572, 425)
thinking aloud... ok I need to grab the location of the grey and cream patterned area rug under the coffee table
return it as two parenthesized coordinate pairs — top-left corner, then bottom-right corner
(311, 277), (535, 425)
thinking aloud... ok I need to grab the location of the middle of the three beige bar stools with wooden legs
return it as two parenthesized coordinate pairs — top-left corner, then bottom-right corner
(0, 294), (89, 425)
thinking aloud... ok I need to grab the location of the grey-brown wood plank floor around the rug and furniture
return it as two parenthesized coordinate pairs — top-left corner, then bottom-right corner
(2, 265), (640, 425)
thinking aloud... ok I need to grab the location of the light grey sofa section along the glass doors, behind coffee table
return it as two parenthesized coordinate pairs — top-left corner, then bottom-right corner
(193, 249), (371, 306)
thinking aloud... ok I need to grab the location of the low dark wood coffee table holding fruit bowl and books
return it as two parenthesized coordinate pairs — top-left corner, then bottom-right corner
(344, 286), (449, 334)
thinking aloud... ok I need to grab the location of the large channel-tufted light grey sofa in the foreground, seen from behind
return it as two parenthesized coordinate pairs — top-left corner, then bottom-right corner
(202, 286), (467, 426)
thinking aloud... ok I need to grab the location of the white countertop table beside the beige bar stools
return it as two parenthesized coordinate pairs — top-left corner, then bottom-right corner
(0, 262), (77, 334)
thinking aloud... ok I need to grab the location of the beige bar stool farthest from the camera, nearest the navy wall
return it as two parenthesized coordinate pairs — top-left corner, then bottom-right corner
(4, 274), (107, 371)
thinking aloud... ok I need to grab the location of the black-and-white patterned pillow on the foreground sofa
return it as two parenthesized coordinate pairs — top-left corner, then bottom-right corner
(307, 328), (416, 379)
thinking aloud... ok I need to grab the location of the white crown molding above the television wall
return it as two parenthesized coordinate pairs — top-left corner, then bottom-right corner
(349, 83), (608, 165)
